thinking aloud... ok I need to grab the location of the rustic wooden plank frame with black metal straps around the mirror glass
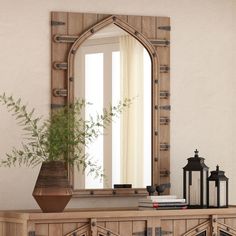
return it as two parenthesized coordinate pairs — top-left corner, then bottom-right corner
(51, 12), (170, 197)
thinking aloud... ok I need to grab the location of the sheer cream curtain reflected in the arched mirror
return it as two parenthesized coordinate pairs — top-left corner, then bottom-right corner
(120, 35), (144, 187)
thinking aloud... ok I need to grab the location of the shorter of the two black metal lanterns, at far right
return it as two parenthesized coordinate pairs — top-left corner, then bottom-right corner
(207, 165), (228, 208)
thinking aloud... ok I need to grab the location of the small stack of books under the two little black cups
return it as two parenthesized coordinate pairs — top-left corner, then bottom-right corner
(138, 195), (187, 210)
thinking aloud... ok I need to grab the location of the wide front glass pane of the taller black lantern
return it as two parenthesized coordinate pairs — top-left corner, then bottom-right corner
(189, 171), (201, 205)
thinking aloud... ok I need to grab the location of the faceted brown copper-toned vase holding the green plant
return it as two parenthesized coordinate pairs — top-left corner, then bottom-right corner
(33, 161), (72, 212)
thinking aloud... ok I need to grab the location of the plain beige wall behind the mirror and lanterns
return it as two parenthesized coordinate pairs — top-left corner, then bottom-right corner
(0, 0), (236, 209)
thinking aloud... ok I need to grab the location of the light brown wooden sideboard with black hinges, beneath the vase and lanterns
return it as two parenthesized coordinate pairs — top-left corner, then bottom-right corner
(0, 208), (236, 236)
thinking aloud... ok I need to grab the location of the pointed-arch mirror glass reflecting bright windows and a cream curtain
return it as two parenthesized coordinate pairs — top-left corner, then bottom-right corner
(74, 24), (152, 189)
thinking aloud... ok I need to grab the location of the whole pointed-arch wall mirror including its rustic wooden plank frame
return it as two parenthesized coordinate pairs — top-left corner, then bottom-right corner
(52, 12), (170, 197)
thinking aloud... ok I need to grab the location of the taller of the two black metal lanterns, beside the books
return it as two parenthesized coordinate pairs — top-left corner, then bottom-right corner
(183, 150), (209, 208)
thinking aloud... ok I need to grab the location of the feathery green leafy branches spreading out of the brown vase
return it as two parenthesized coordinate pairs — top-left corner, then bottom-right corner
(0, 93), (131, 178)
